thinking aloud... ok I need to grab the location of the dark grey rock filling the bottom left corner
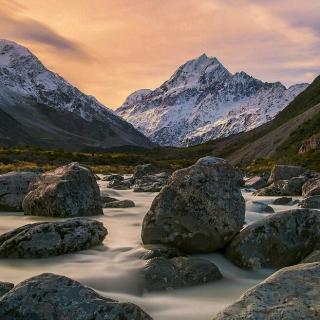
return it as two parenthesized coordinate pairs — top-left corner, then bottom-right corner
(0, 274), (152, 320)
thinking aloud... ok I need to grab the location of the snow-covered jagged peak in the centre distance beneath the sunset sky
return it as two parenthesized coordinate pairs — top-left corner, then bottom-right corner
(116, 54), (307, 146)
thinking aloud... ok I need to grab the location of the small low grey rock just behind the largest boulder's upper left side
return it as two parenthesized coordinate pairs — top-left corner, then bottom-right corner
(132, 172), (171, 192)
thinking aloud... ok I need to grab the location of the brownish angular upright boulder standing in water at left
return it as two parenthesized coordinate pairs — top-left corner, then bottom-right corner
(22, 162), (103, 217)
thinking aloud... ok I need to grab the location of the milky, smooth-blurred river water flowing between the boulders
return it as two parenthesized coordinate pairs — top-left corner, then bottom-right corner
(0, 181), (295, 320)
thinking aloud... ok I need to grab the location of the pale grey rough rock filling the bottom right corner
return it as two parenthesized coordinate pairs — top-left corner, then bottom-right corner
(213, 263), (320, 320)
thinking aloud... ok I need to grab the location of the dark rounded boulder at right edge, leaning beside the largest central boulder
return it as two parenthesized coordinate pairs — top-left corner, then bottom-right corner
(226, 209), (320, 269)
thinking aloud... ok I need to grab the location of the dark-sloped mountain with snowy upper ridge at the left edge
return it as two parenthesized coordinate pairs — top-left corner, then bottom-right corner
(0, 40), (153, 150)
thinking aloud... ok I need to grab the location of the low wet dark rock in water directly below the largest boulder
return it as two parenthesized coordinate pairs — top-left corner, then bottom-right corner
(143, 257), (222, 291)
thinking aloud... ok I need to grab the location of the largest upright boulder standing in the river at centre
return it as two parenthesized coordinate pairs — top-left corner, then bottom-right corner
(142, 157), (245, 253)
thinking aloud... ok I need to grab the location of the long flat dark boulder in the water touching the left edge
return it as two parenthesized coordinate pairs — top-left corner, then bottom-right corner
(0, 218), (108, 258)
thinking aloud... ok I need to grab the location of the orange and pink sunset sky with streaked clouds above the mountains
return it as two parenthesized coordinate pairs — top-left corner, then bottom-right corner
(0, 0), (320, 108)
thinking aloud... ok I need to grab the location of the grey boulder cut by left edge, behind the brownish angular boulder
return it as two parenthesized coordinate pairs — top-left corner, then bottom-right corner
(0, 171), (38, 211)
